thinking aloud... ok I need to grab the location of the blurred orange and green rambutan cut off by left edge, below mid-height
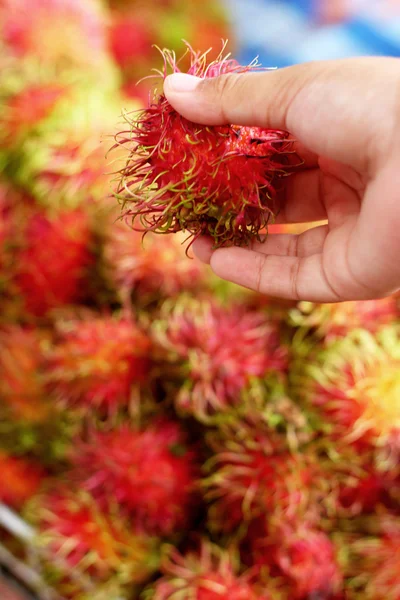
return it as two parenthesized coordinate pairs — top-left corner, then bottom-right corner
(0, 325), (79, 467)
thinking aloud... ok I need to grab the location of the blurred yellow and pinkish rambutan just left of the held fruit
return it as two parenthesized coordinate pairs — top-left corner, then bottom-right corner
(12, 81), (131, 211)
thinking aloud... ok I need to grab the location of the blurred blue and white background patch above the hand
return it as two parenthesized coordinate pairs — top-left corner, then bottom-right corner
(226, 0), (400, 67)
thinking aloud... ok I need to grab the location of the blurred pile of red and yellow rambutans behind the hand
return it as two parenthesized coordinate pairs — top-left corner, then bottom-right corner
(0, 0), (400, 600)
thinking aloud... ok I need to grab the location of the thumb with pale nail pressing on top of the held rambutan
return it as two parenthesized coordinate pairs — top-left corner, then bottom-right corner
(164, 58), (400, 171)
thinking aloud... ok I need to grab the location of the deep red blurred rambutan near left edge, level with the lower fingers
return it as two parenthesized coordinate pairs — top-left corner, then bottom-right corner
(16, 209), (93, 317)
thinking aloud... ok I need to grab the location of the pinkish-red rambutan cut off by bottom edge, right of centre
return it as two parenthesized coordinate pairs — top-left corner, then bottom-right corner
(247, 520), (343, 600)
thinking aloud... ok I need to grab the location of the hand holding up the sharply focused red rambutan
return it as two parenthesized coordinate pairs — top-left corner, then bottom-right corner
(164, 58), (400, 302)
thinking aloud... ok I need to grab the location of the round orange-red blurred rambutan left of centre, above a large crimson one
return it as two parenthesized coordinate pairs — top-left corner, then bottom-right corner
(47, 315), (150, 413)
